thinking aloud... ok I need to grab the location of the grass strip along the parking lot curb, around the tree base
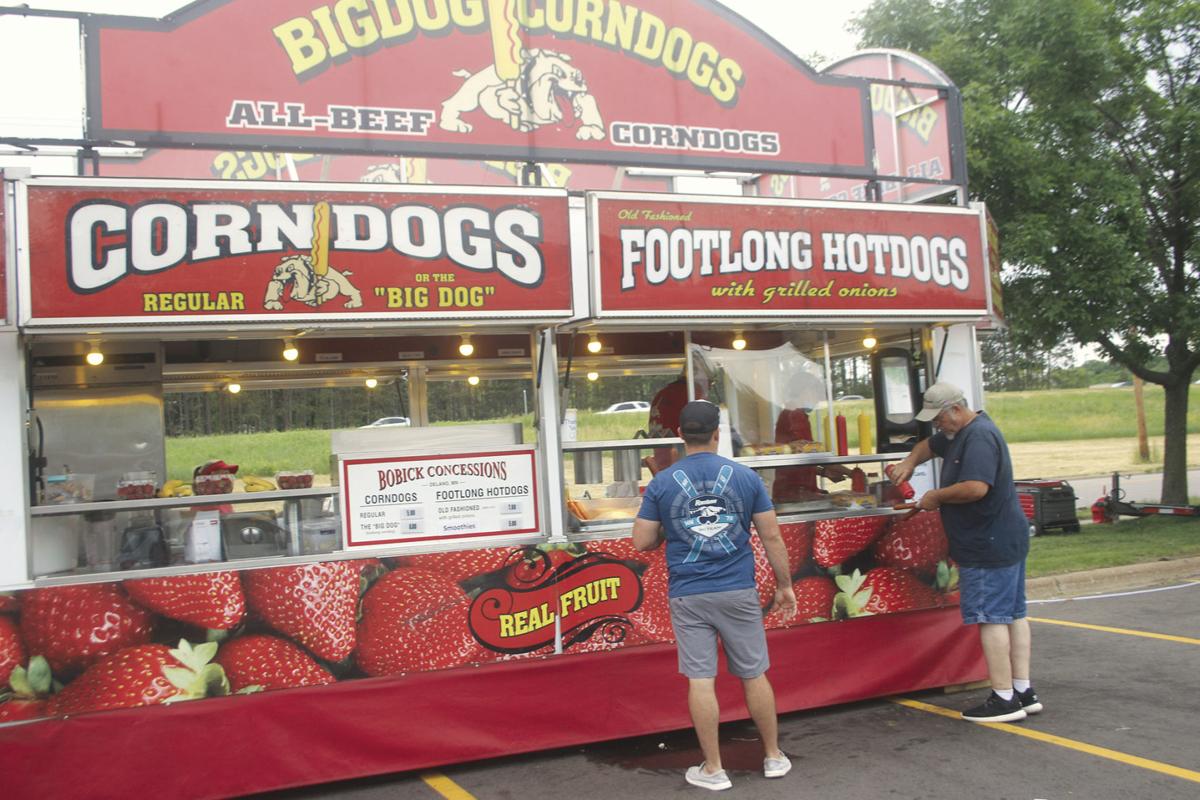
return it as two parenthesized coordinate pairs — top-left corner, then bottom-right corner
(1026, 517), (1200, 578)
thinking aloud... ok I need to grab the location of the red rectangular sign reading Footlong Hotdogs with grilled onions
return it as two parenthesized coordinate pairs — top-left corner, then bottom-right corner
(589, 193), (989, 319)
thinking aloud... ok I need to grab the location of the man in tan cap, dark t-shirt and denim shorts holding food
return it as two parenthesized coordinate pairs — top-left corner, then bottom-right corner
(892, 381), (1042, 722)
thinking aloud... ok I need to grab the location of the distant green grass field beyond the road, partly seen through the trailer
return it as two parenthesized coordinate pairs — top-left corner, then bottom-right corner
(167, 386), (1200, 479)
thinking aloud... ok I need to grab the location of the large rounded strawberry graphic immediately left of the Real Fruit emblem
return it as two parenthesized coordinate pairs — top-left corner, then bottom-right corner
(355, 567), (485, 675)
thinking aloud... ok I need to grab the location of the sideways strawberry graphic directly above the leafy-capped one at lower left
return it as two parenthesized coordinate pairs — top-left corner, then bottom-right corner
(124, 572), (246, 631)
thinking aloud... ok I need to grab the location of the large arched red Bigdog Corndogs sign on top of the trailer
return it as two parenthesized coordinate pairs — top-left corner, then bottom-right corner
(84, 0), (872, 175)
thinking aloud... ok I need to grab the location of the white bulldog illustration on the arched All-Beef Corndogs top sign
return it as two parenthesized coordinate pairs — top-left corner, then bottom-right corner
(438, 48), (605, 140)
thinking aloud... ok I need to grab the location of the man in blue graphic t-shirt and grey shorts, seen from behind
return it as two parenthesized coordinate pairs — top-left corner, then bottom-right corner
(634, 401), (796, 789)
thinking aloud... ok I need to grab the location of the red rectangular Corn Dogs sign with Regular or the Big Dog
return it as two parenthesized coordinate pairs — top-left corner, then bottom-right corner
(19, 180), (571, 325)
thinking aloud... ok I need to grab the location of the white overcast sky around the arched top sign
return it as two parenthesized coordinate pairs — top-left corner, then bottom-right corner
(0, 0), (870, 139)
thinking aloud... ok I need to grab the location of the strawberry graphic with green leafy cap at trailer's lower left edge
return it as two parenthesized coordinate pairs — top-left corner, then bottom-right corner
(47, 640), (229, 714)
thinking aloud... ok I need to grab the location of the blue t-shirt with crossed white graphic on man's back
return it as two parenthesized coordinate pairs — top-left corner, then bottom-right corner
(637, 452), (774, 597)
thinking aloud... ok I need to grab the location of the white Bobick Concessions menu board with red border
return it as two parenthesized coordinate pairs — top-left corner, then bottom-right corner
(338, 447), (539, 549)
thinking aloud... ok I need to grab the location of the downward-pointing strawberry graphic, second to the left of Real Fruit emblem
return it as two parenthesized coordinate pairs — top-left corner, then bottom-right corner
(242, 561), (359, 661)
